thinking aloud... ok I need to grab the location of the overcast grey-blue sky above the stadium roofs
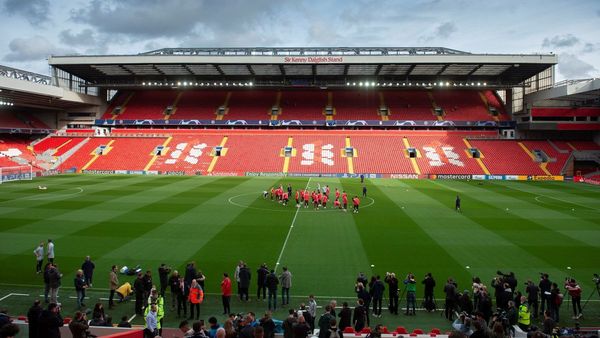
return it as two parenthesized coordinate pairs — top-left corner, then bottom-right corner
(0, 0), (600, 80)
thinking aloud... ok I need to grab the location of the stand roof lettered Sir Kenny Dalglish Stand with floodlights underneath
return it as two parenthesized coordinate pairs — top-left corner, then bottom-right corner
(49, 47), (557, 88)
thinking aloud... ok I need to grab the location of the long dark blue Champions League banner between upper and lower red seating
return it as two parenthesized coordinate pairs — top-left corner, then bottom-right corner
(95, 119), (515, 128)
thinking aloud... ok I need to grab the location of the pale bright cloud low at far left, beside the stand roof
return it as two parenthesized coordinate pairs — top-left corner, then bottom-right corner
(3, 35), (74, 62)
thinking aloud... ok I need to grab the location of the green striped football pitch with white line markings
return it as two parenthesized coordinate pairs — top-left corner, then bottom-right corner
(0, 175), (600, 330)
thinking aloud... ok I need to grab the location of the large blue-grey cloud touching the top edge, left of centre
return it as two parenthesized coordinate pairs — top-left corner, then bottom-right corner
(70, 0), (278, 41)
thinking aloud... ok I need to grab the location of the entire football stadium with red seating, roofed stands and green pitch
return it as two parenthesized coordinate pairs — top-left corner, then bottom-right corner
(0, 27), (600, 338)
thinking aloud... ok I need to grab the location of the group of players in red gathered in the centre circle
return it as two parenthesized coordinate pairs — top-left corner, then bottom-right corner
(263, 184), (360, 213)
